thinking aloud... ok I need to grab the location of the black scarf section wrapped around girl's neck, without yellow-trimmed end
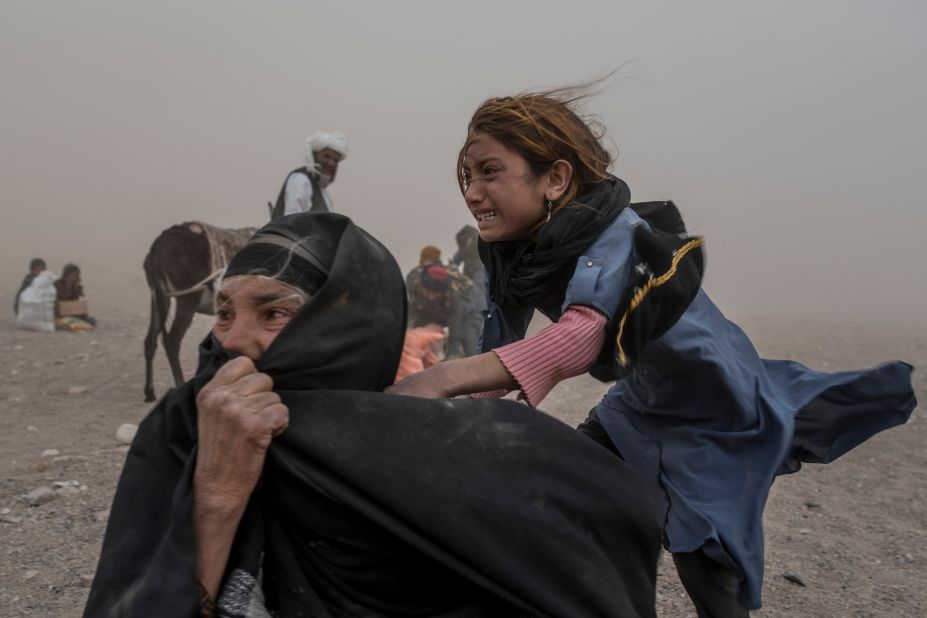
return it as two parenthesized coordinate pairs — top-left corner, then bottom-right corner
(479, 176), (631, 314)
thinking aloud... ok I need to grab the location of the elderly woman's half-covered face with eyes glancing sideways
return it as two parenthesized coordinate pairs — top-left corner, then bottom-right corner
(212, 275), (303, 362)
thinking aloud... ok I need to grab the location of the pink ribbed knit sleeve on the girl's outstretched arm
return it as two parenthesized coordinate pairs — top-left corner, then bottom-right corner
(474, 305), (608, 407)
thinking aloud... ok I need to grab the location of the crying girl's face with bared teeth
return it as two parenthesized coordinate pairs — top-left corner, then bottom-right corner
(463, 133), (548, 242)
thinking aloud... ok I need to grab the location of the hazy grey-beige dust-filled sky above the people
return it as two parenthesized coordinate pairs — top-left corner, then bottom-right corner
(0, 0), (927, 326)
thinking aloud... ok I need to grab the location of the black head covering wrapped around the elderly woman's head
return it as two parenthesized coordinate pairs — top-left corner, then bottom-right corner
(198, 213), (406, 390)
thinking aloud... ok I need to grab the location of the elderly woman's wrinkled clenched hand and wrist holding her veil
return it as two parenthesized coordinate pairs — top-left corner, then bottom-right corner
(194, 356), (289, 508)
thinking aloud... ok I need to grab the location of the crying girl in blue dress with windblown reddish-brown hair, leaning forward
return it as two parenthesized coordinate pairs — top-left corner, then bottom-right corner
(390, 89), (915, 618)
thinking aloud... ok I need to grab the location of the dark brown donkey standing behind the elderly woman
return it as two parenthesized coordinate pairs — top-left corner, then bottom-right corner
(144, 221), (255, 401)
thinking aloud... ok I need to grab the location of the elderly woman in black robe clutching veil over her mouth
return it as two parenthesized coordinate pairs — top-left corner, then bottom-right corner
(85, 213), (660, 617)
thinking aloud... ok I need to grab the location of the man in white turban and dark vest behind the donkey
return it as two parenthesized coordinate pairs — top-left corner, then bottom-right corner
(268, 131), (348, 220)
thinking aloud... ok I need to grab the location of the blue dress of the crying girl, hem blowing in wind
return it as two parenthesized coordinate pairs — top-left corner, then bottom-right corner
(482, 208), (916, 609)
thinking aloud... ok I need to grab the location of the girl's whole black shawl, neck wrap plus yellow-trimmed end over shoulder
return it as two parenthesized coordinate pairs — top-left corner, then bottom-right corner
(479, 176), (705, 381)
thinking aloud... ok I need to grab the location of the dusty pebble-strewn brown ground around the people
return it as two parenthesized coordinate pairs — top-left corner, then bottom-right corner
(0, 282), (927, 618)
